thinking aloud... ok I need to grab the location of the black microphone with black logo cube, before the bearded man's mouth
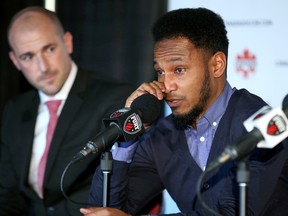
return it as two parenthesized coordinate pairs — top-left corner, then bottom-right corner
(71, 94), (161, 163)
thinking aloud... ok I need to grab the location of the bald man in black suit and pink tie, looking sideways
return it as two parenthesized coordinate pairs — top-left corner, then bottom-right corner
(0, 7), (132, 216)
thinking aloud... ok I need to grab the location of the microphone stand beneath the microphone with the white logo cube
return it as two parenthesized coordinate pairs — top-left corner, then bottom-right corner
(237, 157), (250, 216)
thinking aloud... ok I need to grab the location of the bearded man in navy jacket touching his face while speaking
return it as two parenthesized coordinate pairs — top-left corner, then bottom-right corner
(81, 8), (288, 216)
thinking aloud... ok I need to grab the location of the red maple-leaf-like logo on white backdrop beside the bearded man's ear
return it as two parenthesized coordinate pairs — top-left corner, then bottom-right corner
(236, 49), (256, 78)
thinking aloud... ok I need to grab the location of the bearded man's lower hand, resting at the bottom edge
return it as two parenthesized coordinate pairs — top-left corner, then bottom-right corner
(80, 207), (130, 216)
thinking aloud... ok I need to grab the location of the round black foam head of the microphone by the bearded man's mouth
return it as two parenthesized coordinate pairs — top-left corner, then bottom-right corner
(131, 93), (161, 123)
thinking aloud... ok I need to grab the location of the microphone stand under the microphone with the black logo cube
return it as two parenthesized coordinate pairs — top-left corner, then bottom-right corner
(101, 151), (113, 207)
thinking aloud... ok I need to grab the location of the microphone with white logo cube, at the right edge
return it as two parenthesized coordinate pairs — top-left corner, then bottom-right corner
(205, 95), (288, 172)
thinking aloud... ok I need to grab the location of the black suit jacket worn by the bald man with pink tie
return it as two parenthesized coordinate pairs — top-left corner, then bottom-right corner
(0, 69), (132, 216)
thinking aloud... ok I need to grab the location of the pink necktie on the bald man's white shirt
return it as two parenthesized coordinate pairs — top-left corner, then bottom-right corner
(38, 100), (61, 196)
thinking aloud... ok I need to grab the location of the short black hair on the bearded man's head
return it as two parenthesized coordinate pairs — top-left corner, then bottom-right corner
(152, 8), (229, 58)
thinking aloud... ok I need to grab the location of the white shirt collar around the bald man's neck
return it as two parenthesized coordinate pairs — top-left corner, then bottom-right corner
(38, 61), (78, 104)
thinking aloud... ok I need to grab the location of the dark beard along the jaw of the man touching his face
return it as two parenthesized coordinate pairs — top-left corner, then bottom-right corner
(172, 71), (210, 130)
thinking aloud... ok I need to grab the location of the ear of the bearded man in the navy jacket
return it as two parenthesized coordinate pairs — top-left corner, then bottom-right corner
(212, 51), (227, 78)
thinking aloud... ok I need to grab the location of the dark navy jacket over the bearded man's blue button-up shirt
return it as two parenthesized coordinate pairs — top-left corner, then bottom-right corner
(90, 90), (288, 216)
